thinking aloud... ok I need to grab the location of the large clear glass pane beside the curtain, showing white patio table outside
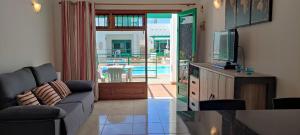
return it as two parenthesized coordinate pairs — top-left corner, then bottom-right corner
(96, 31), (147, 83)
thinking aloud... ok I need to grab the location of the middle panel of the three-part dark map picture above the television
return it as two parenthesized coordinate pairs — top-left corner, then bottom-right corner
(236, 0), (251, 27)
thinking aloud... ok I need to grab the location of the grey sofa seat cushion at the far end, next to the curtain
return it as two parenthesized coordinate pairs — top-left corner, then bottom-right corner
(60, 92), (94, 114)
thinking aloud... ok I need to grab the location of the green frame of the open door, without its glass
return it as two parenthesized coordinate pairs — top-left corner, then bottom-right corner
(176, 8), (197, 102)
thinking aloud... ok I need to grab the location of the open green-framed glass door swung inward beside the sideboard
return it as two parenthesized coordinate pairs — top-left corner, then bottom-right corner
(177, 9), (197, 105)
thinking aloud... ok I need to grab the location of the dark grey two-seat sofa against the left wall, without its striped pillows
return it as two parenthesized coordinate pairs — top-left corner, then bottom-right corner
(0, 64), (94, 135)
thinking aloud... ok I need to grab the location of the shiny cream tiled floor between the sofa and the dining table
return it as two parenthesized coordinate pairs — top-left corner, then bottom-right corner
(78, 99), (189, 135)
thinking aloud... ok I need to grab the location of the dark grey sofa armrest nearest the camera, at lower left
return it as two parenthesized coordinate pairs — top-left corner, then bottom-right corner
(0, 105), (66, 121)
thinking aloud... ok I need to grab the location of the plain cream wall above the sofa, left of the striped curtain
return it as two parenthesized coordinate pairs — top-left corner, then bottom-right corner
(0, 0), (54, 73)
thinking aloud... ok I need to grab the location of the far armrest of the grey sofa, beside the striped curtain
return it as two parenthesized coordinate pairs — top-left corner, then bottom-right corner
(66, 80), (94, 92)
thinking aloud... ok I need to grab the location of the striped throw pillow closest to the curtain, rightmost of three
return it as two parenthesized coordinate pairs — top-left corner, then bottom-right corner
(50, 80), (71, 99)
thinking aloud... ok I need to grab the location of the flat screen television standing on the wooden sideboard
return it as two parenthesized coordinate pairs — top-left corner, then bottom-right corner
(213, 29), (239, 64)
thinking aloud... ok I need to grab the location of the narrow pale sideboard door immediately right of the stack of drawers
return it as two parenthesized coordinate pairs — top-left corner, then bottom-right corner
(200, 69), (208, 101)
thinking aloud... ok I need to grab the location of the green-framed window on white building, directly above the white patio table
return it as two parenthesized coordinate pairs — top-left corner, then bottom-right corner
(112, 40), (131, 57)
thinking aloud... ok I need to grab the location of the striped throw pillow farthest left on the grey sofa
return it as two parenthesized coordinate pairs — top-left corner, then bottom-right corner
(17, 91), (41, 106)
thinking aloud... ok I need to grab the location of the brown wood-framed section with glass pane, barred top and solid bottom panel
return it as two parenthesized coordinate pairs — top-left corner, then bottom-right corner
(95, 10), (148, 100)
